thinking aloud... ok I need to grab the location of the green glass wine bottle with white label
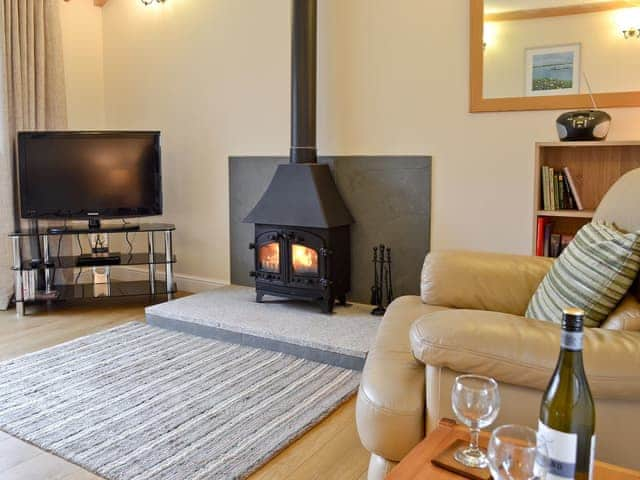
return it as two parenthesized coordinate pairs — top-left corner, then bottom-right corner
(538, 308), (596, 480)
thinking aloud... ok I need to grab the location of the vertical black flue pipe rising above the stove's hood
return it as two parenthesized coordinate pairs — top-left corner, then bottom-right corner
(290, 0), (318, 163)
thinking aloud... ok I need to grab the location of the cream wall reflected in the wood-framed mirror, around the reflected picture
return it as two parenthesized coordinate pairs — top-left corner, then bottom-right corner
(484, 9), (640, 98)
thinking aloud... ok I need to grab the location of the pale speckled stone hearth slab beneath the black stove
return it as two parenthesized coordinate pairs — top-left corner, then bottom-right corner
(146, 286), (380, 370)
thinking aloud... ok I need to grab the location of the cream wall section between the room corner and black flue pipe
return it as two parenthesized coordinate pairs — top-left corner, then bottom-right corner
(103, 0), (290, 281)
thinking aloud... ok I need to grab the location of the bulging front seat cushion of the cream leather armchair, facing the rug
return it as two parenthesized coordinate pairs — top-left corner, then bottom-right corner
(356, 296), (446, 461)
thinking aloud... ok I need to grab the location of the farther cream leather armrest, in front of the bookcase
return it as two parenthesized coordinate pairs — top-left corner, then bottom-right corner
(420, 251), (553, 315)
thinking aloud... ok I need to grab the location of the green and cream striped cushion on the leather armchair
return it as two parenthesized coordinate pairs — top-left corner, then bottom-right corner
(526, 223), (640, 327)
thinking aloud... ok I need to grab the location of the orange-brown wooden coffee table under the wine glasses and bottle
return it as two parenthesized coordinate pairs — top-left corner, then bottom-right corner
(387, 419), (640, 480)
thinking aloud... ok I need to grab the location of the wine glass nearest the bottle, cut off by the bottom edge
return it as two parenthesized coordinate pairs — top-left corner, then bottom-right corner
(487, 425), (549, 480)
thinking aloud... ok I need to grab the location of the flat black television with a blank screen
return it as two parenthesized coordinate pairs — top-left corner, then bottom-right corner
(18, 131), (162, 220)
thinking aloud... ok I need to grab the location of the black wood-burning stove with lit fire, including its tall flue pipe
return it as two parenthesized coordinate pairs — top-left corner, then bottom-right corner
(244, 0), (353, 313)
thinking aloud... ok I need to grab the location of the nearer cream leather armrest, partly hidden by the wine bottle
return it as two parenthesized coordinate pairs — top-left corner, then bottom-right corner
(411, 310), (640, 401)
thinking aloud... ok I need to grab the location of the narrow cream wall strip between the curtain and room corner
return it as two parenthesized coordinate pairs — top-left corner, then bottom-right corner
(58, 0), (105, 130)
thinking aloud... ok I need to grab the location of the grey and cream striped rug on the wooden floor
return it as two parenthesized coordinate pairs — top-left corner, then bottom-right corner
(0, 323), (360, 480)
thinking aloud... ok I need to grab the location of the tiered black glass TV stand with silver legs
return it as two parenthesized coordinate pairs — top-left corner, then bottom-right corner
(9, 223), (177, 316)
